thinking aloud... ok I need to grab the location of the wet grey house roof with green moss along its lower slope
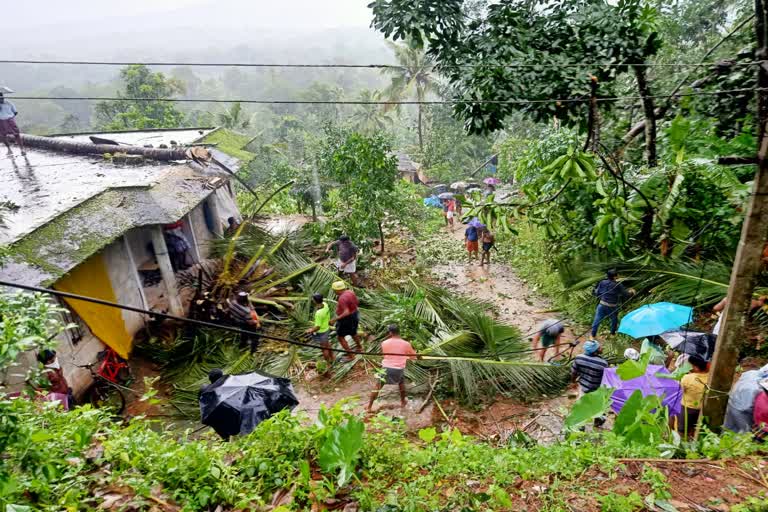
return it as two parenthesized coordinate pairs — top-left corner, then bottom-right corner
(0, 130), (238, 284)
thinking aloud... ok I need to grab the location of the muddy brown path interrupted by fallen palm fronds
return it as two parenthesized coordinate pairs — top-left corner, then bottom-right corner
(288, 226), (577, 443)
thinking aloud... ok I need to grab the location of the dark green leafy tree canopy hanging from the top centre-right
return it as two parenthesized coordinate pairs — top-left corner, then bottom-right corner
(370, 0), (659, 140)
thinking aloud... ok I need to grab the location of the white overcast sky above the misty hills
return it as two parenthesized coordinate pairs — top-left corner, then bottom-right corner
(11, 0), (371, 30)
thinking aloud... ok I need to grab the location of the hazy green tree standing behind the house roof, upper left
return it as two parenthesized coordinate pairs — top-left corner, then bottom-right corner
(96, 64), (184, 130)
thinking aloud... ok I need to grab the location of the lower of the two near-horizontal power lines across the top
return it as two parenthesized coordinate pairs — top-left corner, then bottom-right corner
(13, 88), (763, 105)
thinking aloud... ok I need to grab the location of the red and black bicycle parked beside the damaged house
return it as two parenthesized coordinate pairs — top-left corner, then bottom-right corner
(75, 348), (130, 415)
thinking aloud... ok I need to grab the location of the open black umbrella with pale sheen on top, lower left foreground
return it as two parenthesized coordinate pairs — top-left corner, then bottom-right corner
(200, 372), (299, 439)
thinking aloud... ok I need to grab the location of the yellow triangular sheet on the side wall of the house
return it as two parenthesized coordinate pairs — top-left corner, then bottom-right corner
(53, 254), (133, 359)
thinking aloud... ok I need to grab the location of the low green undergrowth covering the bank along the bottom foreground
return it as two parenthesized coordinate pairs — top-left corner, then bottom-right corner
(0, 394), (764, 512)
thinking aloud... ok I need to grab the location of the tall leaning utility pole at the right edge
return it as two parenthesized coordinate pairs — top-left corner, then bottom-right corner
(703, 0), (768, 427)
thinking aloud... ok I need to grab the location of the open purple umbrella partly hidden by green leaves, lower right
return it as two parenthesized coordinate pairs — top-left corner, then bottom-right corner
(602, 364), (683, 416)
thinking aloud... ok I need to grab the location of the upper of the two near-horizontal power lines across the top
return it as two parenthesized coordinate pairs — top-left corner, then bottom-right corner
(0, 59), (760, 69)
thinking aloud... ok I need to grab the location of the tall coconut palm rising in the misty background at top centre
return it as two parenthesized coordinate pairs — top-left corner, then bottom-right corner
(383, 42), (438, 153)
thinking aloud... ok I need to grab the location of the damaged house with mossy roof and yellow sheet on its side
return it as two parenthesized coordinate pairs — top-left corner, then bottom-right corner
(0, 128), (246, 394)
